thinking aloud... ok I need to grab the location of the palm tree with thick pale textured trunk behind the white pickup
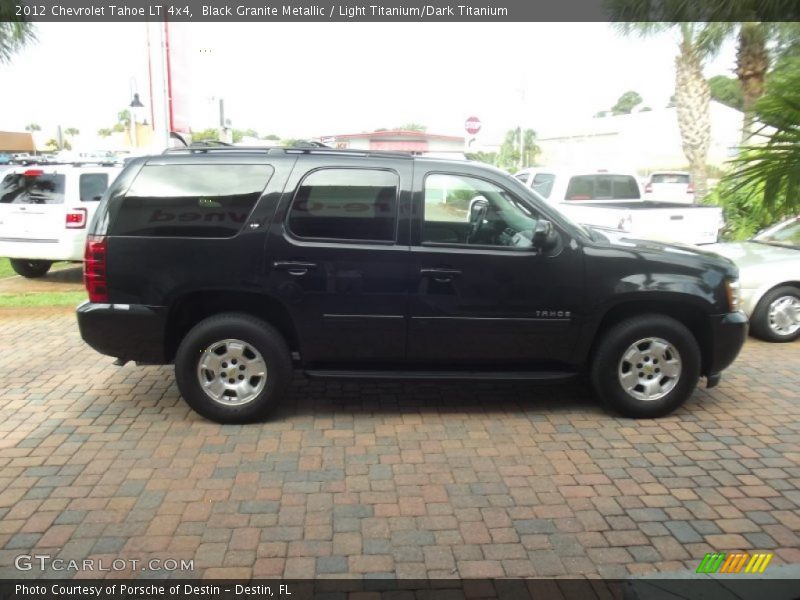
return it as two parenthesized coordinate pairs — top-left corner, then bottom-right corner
(617, 22), (728, 200)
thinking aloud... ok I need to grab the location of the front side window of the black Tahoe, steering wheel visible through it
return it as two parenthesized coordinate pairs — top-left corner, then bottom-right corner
(422, 173), (538, 247)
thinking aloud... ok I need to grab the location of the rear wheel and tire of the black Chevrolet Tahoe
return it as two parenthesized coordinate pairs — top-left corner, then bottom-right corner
(175, 313), (292, 423)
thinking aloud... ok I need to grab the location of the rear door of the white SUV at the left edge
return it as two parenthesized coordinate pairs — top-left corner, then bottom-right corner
(0, 167), (67, 243)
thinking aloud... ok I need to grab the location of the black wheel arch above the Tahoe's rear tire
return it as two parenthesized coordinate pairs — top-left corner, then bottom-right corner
(164, 290), (300, 361)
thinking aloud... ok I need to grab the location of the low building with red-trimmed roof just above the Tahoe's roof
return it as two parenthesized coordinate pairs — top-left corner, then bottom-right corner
(315, 129), (464, 157)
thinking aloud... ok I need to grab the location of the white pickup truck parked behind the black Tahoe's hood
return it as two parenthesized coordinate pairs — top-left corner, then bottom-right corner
(514, 168), (725, 244)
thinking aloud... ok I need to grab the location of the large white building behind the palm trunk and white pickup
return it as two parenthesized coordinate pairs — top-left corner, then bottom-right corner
(536, 102), (743, 175)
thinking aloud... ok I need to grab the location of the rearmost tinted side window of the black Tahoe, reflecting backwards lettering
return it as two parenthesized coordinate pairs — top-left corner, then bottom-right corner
(109, 164), (273, 238)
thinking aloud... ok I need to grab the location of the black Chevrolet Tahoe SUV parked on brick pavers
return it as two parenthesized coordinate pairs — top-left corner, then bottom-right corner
(77, 148), (747, 423)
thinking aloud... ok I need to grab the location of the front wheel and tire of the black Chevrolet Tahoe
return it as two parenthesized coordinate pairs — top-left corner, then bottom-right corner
(591, 314), (701, 418)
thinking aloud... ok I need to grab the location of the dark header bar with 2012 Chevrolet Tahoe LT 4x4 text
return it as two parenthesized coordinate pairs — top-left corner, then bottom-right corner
(0, 0), (800, 23)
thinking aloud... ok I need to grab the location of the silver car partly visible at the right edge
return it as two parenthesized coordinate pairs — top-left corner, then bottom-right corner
(709, 216), (800, 342)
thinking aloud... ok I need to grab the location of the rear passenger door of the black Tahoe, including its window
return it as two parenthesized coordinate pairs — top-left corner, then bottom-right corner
(266, 154), (413, 368)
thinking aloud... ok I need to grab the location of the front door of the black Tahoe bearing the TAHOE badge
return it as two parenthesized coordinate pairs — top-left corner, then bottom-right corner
(408, 172), (584, 370)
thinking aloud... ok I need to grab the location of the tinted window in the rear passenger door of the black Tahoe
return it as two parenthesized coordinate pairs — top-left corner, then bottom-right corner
(287, 169), (399, 242)
